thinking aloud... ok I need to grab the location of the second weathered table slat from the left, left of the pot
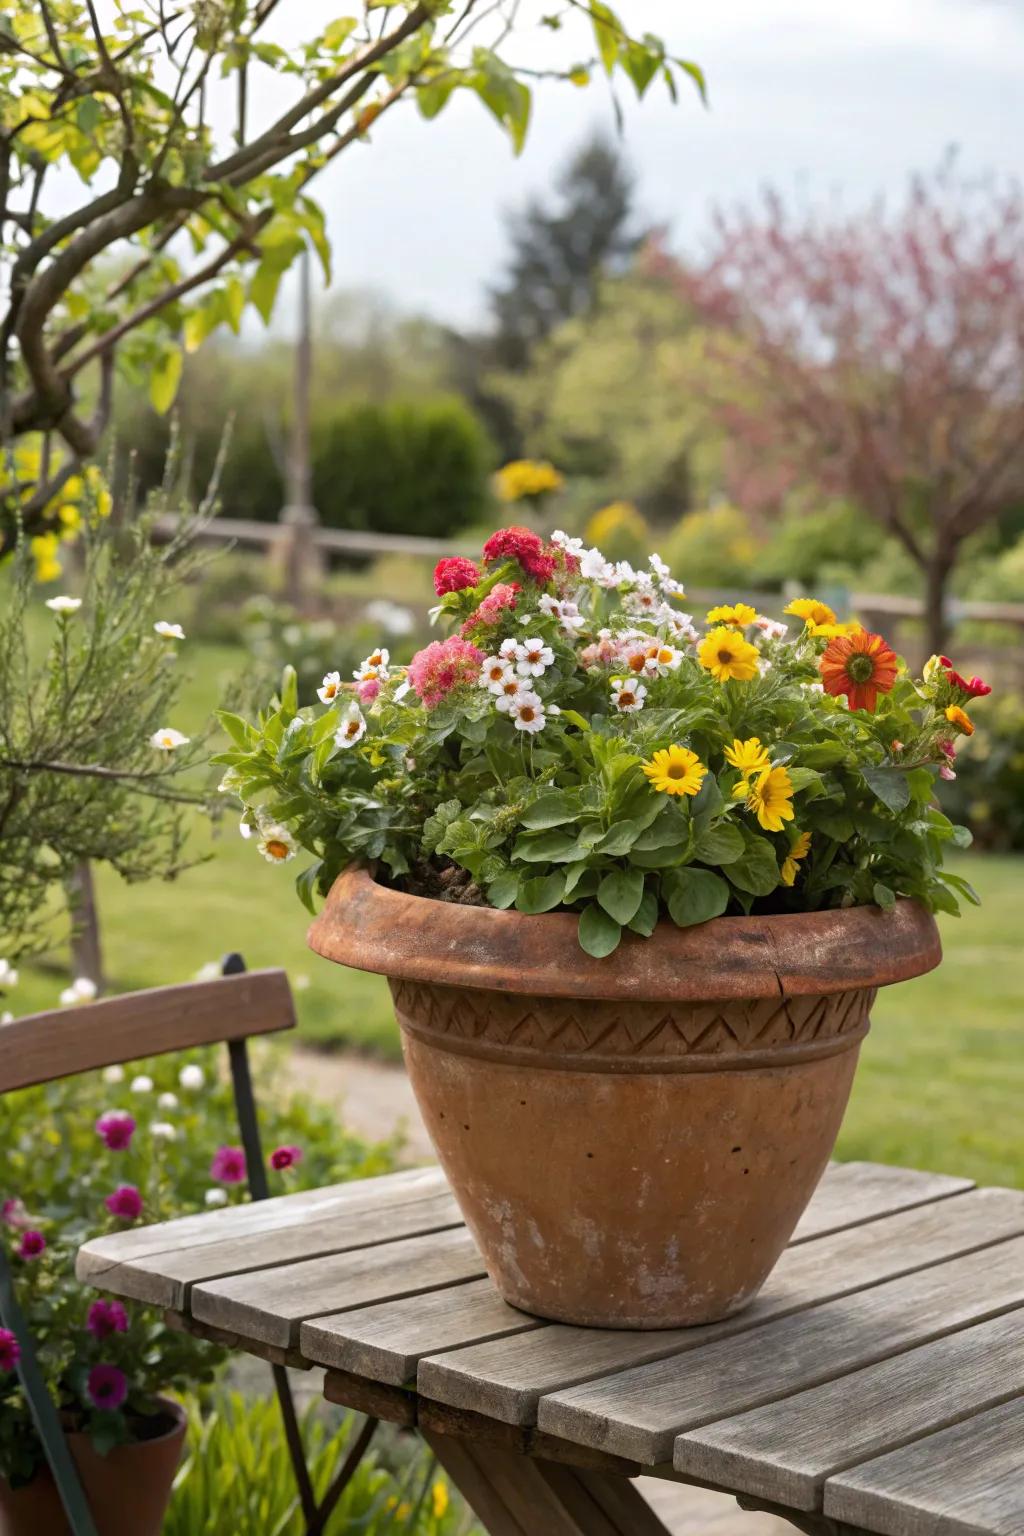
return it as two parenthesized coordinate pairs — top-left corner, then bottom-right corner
(190, 1227), (484, 1346)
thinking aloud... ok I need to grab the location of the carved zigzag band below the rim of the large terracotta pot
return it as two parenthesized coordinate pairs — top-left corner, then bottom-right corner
(391, 982), (875, 1058)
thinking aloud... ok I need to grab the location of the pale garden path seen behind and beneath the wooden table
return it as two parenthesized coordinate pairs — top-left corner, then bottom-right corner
(287, 1046), (794, 1536)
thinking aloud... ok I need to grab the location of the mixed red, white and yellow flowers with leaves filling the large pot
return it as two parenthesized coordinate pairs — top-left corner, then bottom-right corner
(216, 527), (989, 957)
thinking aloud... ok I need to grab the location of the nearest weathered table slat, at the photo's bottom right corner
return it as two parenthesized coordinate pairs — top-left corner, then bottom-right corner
(824, 1398), (1024, 1536)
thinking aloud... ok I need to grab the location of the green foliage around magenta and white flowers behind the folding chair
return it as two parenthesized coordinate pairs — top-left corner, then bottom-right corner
(0, 1049), (391, 1482)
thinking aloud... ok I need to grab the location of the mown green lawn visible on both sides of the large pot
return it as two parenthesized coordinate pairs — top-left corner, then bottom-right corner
(15, 645), (1024, 1187)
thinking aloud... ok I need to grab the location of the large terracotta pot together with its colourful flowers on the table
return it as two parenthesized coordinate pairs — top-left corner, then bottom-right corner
(218, 527), (987, 1327)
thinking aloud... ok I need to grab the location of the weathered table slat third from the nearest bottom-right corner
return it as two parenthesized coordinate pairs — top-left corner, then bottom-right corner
(534, 1234), (1024, 1465)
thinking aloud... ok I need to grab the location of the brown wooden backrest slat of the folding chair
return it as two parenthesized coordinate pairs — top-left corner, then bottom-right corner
(0, 969), (295, 1094)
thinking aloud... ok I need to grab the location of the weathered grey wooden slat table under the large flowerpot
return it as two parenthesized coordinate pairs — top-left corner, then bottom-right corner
(78, 1163), (1024, 1536)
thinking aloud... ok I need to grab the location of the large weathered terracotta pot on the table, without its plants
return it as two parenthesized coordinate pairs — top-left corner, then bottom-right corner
(309, 869), (941, 1329)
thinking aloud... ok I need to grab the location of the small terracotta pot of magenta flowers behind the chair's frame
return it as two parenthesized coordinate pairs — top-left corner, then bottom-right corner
(0, 1398), (186, 1536)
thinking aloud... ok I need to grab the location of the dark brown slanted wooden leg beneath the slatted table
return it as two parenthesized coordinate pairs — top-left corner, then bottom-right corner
(421, 1428), (669, 1536)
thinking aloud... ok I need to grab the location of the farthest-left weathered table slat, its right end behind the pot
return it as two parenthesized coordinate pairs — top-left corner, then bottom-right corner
(75, 1169), (451, 1310)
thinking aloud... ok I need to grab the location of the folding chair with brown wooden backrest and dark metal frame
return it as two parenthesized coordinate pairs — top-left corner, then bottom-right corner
(0, 954), (344, 1536)
